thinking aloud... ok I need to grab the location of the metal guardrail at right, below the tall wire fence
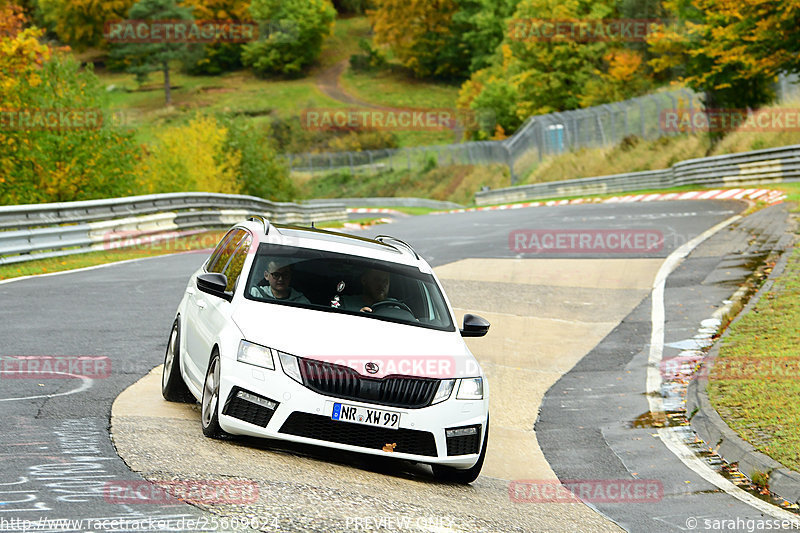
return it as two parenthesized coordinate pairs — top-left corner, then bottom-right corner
(475, 145), (800, 205)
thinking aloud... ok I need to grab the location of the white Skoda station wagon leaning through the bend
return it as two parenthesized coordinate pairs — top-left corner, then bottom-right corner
(162, 217), (489, 483)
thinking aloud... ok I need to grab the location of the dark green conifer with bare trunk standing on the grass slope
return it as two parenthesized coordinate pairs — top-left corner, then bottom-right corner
(111, 0), (194, 105)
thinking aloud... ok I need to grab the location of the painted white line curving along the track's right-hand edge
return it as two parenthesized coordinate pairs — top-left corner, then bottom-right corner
(646, 215), (797, 521)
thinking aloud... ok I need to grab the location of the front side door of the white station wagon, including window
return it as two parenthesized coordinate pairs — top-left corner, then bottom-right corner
(196, 230), (253, 379)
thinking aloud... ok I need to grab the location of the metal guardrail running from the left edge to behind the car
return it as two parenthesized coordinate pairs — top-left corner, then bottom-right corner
(0, 193), (347, 264)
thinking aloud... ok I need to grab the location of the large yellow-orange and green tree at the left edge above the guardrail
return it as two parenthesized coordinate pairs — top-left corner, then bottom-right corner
(0, 19), (138, 205)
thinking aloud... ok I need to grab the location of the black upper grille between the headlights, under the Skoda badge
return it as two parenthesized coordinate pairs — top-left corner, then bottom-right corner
(299, 358), (439, 409)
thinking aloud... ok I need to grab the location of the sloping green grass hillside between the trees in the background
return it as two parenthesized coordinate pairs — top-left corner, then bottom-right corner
(96, 16), (466, 146)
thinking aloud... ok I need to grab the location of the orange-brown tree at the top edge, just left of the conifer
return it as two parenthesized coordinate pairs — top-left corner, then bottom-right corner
(38, 0), (136, 50)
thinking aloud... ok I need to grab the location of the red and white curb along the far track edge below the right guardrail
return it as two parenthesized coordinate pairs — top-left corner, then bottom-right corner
(431, 189), (786, 215)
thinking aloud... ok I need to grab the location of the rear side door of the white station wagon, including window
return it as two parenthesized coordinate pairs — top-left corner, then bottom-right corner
(181, 228), (247, 387)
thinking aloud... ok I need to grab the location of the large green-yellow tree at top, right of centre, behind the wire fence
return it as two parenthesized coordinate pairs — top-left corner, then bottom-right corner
(458, 0), (660, 138)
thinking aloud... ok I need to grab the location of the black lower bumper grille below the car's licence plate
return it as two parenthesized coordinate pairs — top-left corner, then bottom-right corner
(280, 412), (436, 457)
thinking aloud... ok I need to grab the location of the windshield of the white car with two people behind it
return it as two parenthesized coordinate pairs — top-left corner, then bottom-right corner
(245, 244), (455, 331)
